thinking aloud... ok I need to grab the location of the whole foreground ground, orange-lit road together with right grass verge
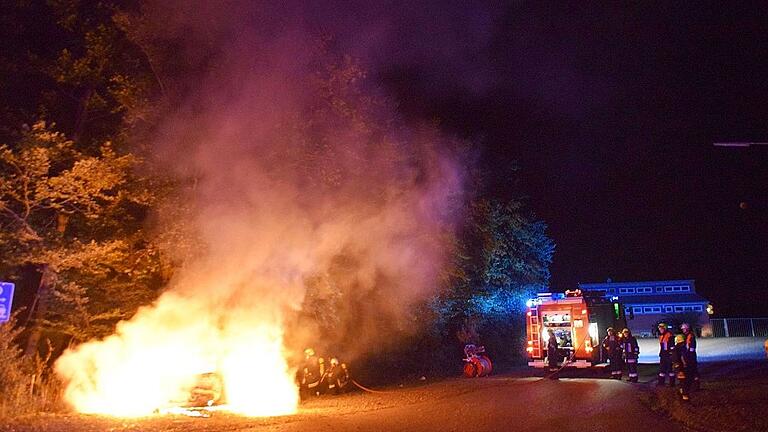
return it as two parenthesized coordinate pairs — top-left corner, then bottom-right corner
(6, 352), (768, 432)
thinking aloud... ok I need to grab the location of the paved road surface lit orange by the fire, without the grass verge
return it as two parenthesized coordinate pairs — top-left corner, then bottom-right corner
(0, 375), (682, 432)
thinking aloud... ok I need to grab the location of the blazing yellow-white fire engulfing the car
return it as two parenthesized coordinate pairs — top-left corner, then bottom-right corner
(56, 293), (298, 417)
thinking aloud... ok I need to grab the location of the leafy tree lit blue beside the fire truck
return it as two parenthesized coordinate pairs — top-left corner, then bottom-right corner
(429, 199), (555, 370)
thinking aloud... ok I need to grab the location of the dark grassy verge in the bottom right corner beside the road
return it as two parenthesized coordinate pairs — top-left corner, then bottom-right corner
(641, 361), (768, 432)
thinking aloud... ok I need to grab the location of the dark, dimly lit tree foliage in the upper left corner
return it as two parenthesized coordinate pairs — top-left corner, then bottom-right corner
(0, 0), (156, 145)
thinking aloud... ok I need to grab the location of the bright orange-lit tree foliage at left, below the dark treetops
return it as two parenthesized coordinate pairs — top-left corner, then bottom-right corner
(0, 121), (161, 348)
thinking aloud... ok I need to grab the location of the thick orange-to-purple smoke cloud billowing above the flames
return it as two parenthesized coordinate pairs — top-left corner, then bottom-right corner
(140, 2), (463, 356)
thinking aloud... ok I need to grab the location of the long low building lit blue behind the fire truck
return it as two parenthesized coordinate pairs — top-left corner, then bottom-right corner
(579, 280), (712, 337)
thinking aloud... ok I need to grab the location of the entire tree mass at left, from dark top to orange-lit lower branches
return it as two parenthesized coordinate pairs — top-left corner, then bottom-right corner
(0, 0), (168, 355)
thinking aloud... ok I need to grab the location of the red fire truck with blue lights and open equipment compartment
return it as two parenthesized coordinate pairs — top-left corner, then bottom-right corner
(526, 290), (626, 368)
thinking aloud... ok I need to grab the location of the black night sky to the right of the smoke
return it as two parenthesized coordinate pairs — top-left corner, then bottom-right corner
(381, 2), (768, 317)
